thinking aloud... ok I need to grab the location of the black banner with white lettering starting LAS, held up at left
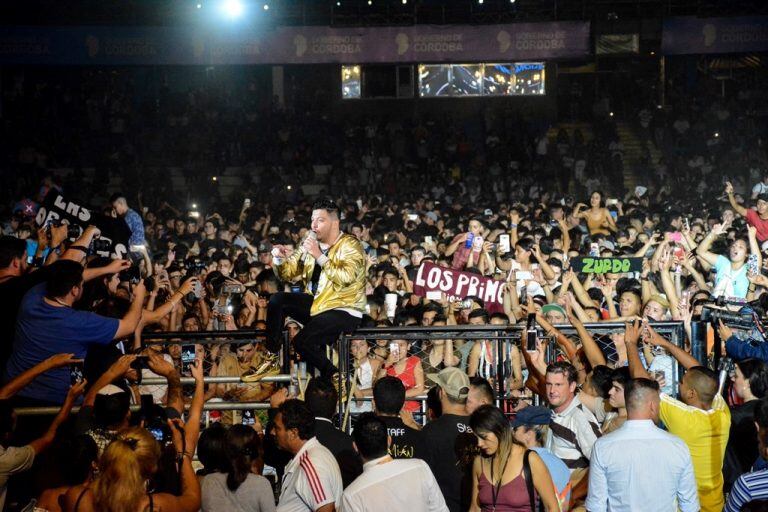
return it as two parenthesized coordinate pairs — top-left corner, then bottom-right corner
(35, 190), (131, 259)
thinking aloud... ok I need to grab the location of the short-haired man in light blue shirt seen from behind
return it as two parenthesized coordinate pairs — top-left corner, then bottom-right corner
(586, 379), (700, 512)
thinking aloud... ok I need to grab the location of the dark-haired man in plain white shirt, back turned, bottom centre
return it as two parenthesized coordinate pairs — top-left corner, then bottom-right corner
(341, 413), (448, 512)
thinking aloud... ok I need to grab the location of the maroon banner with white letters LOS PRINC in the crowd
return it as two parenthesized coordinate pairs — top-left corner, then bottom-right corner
(413, 262), (505, 313)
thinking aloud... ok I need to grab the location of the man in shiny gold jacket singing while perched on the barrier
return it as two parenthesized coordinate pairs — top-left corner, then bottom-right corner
(267, 200), (366, 377)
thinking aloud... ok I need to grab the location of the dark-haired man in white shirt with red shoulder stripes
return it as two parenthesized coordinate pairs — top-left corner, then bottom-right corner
(272, 400), (343, 512)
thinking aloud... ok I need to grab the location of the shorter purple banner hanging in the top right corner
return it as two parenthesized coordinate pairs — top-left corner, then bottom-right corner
(661, 16), (768, 55)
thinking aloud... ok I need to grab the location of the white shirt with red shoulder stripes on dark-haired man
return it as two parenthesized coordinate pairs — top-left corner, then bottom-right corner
(277, 437), (343, 512)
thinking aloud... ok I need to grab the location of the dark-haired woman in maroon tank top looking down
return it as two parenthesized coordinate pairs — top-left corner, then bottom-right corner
(469, 405), (560, 512)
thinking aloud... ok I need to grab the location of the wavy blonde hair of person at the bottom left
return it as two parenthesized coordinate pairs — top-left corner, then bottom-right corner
(93, 427), (160, 512)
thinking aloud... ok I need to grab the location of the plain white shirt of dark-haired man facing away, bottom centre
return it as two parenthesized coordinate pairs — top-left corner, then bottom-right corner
(341, 456), (448, 512)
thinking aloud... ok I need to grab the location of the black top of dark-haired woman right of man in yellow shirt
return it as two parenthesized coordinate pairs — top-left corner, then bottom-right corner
(723, 400), (759, 490)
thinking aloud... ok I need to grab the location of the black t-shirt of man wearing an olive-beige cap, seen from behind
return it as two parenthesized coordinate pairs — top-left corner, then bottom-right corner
(421, 414), (477, 512)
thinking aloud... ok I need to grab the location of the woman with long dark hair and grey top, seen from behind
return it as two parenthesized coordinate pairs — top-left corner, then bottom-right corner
(202, 425), (275, 512)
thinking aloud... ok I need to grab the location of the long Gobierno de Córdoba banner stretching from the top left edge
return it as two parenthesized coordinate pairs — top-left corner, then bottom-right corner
(0, 21), (590, 65)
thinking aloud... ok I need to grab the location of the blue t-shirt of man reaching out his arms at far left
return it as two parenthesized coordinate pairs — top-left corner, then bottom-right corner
(5, 283), (120, 403)
